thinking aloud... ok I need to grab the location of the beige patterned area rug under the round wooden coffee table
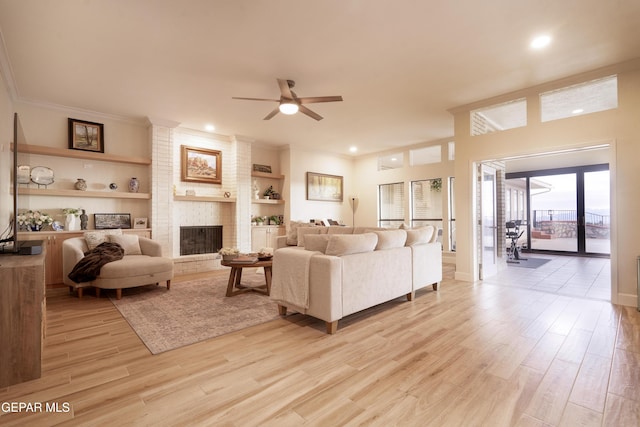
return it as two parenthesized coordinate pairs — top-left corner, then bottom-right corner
(110, 269), (278, 354)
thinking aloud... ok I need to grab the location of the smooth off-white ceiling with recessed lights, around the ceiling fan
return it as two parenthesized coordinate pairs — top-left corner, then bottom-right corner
(0, 0), (640, 155)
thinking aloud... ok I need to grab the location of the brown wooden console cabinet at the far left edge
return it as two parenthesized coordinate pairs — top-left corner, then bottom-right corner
(0, 248), (46, 387)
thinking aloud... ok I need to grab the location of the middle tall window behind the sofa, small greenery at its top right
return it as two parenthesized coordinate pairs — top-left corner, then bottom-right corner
(411, 178), (442, 228)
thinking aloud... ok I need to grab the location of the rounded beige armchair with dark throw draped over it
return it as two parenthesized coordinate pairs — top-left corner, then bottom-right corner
(62, 236), (173, 299)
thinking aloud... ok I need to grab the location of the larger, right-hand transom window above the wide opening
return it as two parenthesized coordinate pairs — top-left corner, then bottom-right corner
(540, 76), (618, 122)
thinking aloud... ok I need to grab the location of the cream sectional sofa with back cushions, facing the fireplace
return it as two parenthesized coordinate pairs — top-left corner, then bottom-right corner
(270, 227), (442, 334)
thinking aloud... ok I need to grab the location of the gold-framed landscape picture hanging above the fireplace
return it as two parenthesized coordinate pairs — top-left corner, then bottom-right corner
(181, 145), (222, 184)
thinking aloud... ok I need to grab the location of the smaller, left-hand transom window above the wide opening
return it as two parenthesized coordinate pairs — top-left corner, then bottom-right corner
(471, 98), (527, 136)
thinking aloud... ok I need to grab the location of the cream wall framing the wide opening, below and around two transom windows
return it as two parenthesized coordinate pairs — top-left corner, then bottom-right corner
(452, 60), (640, 305)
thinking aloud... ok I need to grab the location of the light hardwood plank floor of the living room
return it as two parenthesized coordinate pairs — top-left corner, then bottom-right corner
(0, 265), (640, 426)
